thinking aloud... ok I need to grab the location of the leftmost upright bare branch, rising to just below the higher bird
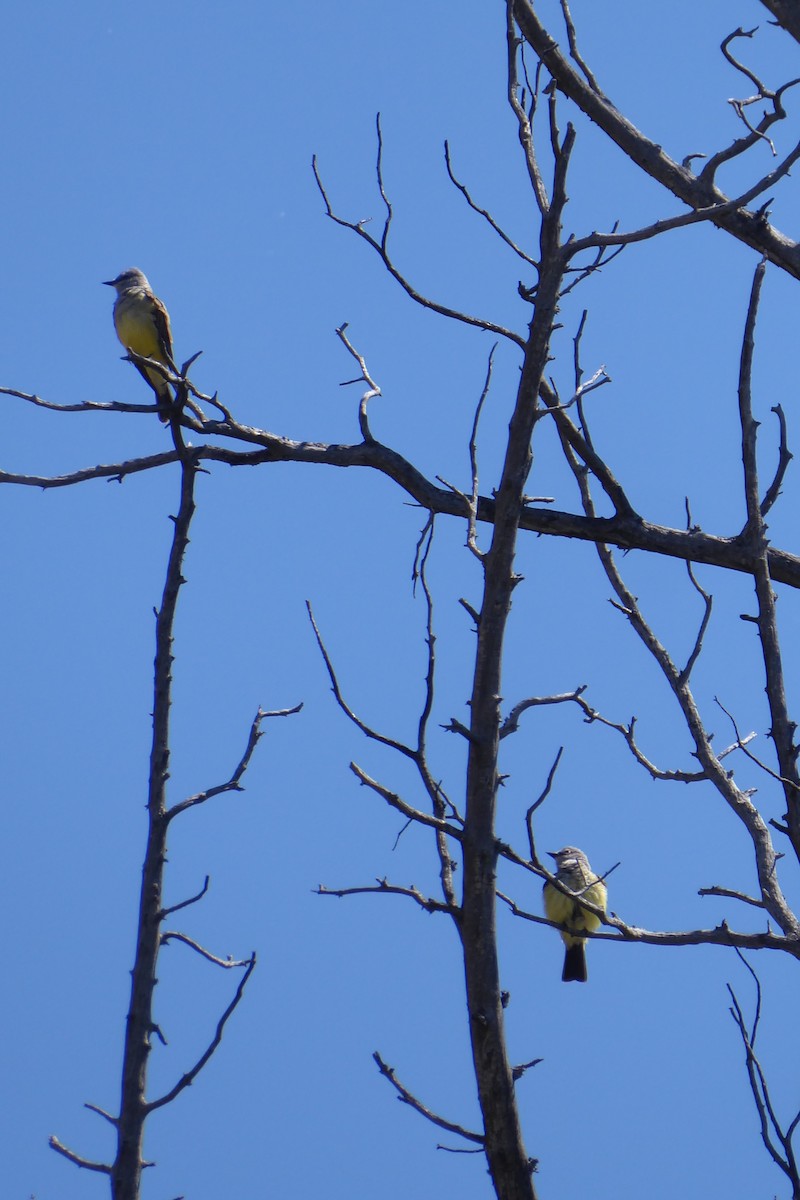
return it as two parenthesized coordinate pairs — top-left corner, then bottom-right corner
(112, 446), (198, 1200)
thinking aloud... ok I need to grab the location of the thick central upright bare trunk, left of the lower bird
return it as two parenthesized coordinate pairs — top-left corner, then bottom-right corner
(462, 42), (575, 1185)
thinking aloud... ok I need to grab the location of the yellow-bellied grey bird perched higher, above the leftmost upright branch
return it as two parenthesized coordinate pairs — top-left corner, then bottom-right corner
(103, 266), (178, 422)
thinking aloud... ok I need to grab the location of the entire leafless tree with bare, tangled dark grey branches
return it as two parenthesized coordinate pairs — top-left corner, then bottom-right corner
(7, 0), (800, 1200)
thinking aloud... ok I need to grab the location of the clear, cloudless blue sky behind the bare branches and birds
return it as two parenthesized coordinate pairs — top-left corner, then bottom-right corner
(0, 0), (800, 1200)
